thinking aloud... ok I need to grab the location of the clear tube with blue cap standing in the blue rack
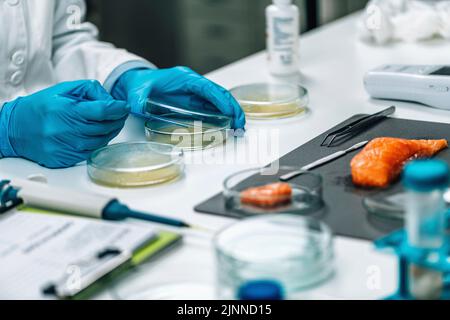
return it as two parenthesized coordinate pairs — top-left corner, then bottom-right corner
(403, 160), (450, 299)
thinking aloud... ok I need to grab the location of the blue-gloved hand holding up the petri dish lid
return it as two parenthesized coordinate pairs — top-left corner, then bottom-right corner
(111, 67), (245, 129)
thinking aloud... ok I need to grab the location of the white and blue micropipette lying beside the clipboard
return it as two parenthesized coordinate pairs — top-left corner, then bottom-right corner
(0, 179), (195, 228)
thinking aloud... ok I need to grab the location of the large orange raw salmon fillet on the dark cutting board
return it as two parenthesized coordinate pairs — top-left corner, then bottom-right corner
(351, 138), (448, 187)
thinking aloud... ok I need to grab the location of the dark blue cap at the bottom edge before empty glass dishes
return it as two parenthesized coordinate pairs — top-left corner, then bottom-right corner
(238, 280), (283, 301)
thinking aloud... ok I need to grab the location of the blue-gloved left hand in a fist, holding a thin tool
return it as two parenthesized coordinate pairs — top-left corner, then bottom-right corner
(0, 80), (130, 168)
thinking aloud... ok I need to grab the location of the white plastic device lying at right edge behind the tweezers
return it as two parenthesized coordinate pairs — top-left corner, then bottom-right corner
(364, 65), (450, 110)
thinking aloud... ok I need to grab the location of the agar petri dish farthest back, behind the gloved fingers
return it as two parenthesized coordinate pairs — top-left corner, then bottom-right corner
(230, 83), (309, 120)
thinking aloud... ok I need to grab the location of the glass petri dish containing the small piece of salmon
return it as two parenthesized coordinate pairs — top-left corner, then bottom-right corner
(223, 167), (323, 216)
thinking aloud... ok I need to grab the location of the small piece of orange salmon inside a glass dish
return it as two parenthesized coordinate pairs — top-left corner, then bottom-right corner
(241, 183), (292, 208)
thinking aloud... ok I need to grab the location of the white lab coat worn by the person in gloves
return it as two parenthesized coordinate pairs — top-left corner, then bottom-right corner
(0, 0), (150, 105)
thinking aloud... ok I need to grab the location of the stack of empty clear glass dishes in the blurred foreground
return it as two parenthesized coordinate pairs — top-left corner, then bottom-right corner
(214, 215), (334, 299)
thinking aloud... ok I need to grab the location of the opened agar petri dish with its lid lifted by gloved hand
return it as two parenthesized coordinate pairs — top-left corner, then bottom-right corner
(145, 101), (232, 151)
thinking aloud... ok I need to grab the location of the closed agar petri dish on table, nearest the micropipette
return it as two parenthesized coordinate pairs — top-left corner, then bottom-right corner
(88, 142), (184, 188)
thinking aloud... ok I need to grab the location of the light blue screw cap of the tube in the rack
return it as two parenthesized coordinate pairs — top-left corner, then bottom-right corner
(403, 160), (450, 192)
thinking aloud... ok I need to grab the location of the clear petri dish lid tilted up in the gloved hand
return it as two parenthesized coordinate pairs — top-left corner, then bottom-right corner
(145, 100), (233, 130)
